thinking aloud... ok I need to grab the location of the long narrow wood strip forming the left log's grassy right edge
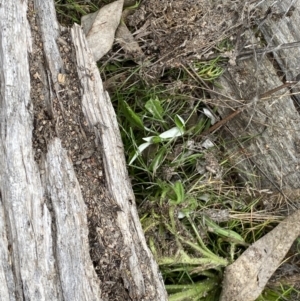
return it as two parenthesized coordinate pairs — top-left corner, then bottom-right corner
(72, 25), (167, 300)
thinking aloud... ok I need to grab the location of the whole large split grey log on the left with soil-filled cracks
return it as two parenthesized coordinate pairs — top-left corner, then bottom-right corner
(0, 0), (167, 301)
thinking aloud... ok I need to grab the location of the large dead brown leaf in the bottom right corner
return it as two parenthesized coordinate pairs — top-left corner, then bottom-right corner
(220, 210), (300, 301)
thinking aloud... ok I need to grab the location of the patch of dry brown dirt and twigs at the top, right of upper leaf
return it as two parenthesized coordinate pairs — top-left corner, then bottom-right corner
(127, 0), (265, 71)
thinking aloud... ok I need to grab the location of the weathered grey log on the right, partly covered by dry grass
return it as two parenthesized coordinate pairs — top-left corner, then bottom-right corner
(214, 0), (300, 192)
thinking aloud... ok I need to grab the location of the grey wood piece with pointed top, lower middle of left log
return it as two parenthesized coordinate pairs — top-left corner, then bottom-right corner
(42, 138), (101, 300)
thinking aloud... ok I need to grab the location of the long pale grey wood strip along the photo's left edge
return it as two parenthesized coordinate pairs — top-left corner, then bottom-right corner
(0, 1), (62, 300)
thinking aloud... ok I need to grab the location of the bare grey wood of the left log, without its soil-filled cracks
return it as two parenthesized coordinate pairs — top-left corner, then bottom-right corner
(0, 0), (167, 301)
